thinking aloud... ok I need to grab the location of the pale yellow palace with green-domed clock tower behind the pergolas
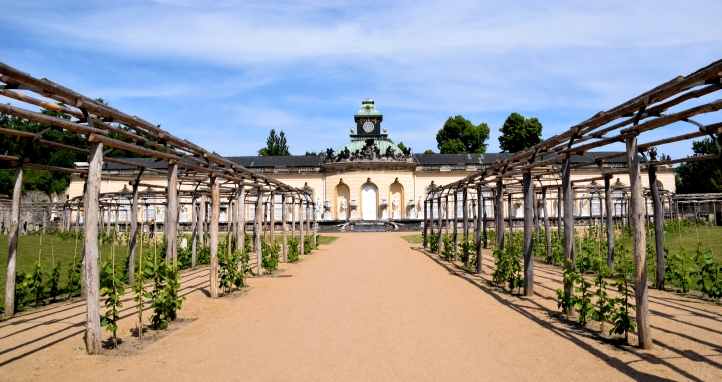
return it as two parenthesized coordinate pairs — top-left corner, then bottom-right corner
(68, 99), (675, 223)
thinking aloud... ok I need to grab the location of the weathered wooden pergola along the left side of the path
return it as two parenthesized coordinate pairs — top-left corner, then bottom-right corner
(0, 63), (317, 354)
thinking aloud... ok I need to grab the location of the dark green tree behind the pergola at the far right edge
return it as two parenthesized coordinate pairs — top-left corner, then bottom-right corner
(676, 135), (722, 194)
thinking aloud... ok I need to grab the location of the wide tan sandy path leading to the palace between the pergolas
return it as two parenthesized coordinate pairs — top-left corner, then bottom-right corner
(0, 233), (720, 381)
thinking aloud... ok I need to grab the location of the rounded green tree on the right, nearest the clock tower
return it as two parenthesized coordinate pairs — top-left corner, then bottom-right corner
(436, 115), (489, 154)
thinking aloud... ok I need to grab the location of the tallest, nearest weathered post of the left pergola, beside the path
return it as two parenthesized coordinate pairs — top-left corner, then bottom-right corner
(83, 143), (103, 354)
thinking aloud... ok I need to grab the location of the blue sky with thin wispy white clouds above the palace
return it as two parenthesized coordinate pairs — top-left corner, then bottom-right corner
(0, 0), (722, 157)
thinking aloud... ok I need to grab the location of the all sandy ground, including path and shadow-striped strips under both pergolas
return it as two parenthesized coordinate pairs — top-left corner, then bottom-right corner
(0, 233), (722, 381)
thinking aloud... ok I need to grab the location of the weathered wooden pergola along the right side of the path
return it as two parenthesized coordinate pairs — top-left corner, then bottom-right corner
(423, 61), (722, 349)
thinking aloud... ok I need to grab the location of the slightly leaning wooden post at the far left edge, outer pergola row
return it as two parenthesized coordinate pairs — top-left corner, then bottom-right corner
(4, 166), (22, 318)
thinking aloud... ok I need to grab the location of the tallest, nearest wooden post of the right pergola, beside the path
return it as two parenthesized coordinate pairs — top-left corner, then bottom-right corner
(626, 136), (652, 349)
